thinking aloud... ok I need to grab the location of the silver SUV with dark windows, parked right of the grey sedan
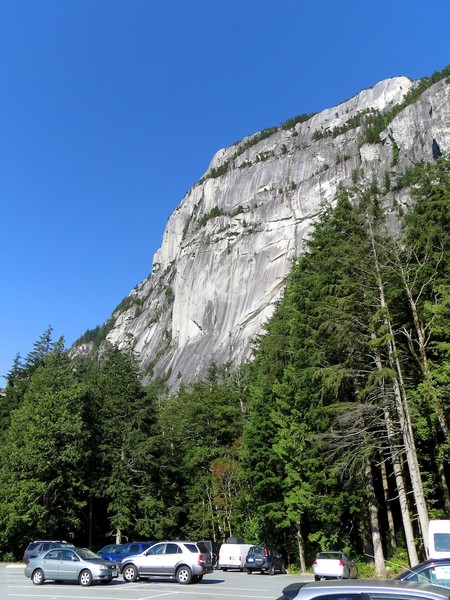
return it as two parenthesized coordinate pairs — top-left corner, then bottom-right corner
(121, 542), (213, 584)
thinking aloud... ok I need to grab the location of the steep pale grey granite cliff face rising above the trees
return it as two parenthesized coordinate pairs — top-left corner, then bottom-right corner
(72, 68), (450, 391)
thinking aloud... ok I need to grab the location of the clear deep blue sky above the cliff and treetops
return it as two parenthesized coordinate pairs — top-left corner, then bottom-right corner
(0, 0), (450, 387)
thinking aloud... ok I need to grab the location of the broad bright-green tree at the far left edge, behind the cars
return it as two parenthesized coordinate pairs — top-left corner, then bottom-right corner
(0, 342), (90, 556)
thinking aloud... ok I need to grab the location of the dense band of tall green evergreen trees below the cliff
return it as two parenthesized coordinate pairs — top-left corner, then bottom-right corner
(0, 157), (450, 576)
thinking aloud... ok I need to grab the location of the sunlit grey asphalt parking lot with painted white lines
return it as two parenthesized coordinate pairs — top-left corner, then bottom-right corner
(0, 564), (312, 600)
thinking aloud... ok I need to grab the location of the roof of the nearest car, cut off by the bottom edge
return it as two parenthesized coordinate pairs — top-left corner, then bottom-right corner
(278, 580), (450, 600)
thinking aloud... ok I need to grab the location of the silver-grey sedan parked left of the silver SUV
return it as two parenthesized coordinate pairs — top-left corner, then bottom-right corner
(25, 547), (119, 586)
